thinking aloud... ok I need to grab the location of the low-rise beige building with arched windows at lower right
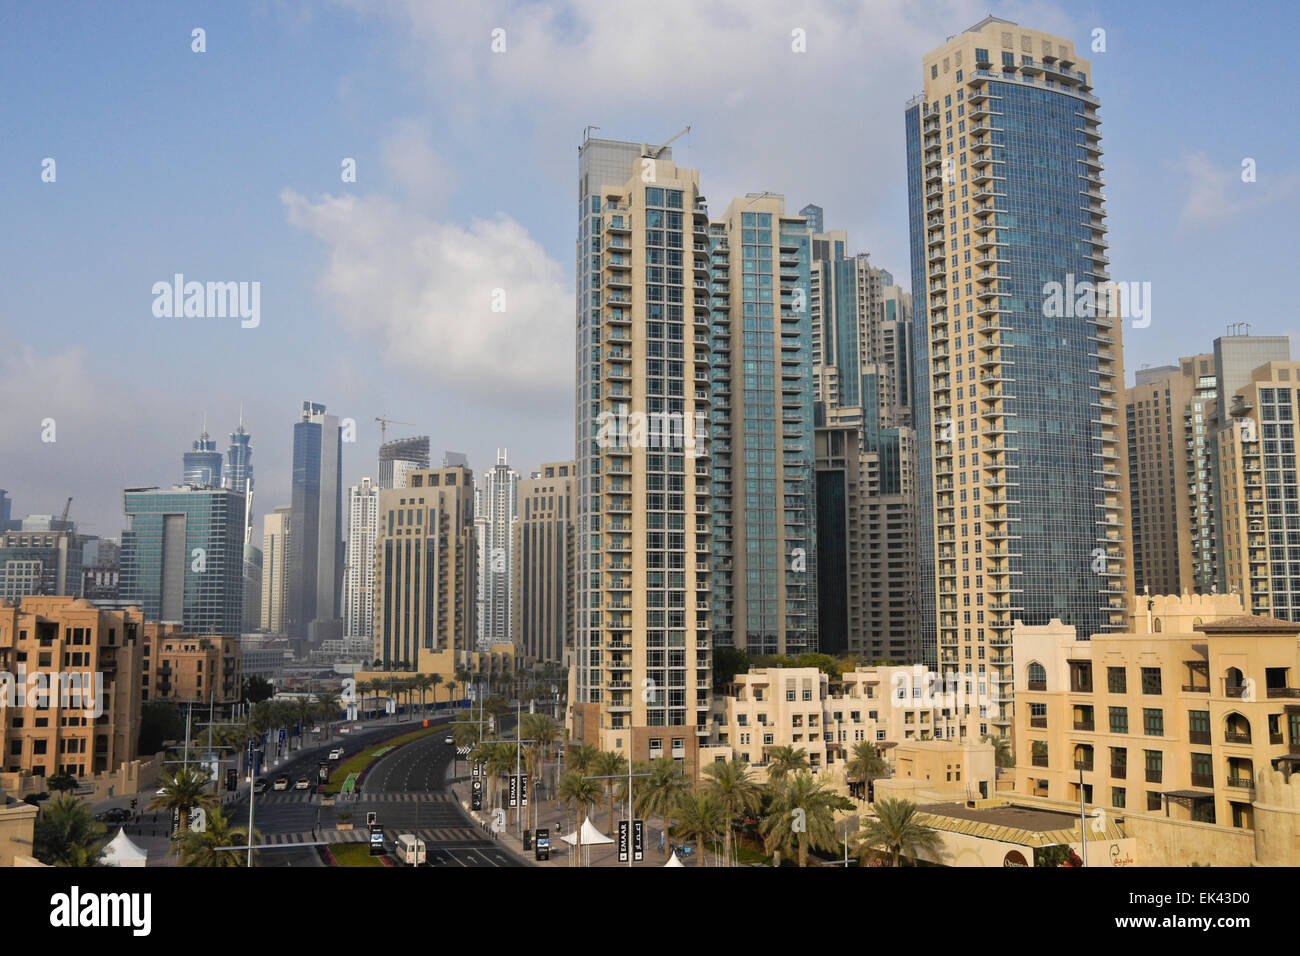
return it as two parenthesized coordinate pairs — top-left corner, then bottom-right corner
(1013, 594), (1300, 864)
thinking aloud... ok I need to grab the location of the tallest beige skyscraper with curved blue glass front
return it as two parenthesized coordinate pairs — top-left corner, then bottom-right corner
(905, 17), (1132, 734)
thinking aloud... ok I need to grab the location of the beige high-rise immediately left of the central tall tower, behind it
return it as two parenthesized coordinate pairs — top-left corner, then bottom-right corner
(511, 462), (576, 663)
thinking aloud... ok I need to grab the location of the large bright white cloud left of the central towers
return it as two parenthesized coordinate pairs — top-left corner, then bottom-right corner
(281, 190), (573, 405)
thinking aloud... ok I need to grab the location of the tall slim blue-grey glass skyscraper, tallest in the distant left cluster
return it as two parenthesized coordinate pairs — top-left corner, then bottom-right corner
(286, 402), (343, 641)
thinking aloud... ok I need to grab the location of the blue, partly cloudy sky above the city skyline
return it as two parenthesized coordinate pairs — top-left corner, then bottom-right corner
(0, 0), (1300, 541)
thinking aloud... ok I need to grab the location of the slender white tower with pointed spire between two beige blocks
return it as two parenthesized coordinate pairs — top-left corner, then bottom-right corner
(475, 450), (519, 649)
